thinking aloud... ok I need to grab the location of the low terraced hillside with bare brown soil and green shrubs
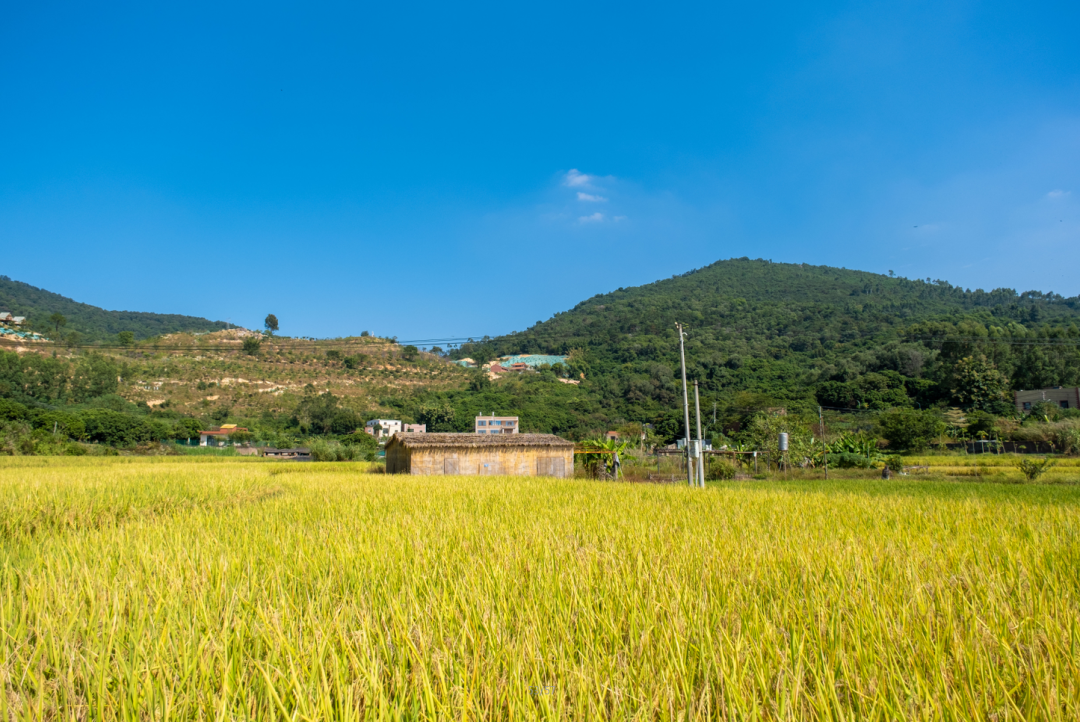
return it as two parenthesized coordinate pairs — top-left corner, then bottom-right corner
(0, 329), (467, 454)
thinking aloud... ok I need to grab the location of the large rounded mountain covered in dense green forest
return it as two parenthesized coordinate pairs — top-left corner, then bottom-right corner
(444, 258), (1080, 436)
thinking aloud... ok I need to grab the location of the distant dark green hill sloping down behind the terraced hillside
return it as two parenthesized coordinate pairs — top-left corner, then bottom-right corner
(0, 276), (226, 342)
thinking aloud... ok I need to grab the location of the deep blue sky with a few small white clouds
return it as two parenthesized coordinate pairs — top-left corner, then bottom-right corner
(0, 1), (1080, 339)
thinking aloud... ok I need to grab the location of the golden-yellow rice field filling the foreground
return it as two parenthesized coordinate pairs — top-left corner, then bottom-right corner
(0, 458), (1080, 720)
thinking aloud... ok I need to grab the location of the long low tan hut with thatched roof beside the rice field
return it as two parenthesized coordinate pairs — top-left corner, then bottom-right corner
(387, 434), (573, 477)
